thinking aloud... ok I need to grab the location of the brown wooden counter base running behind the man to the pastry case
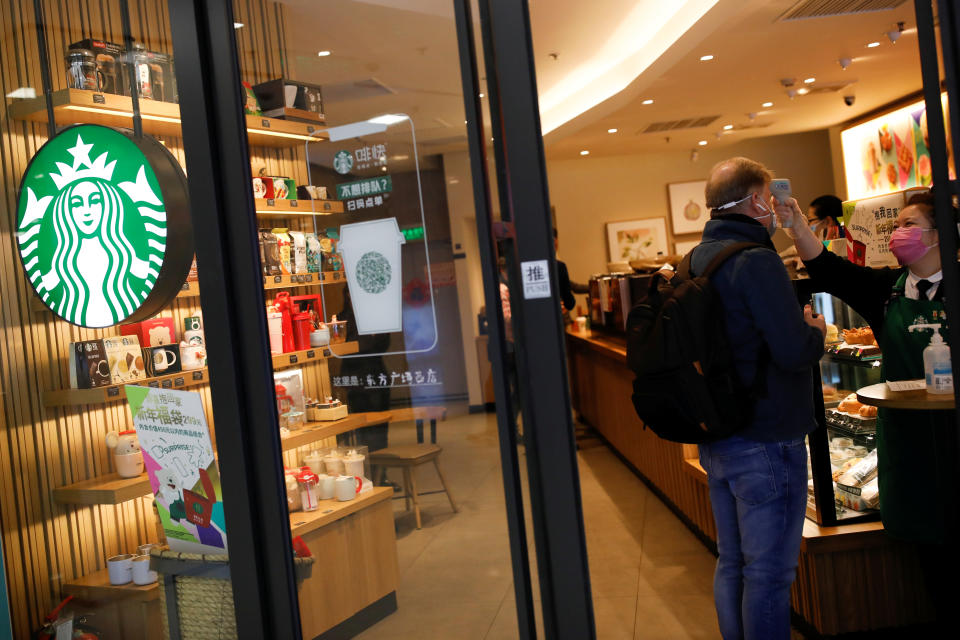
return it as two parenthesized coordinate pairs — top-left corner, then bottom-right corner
(567, 328), (930, 635)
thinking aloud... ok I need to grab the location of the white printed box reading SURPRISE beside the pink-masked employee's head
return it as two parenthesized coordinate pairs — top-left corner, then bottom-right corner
(843, 187), (929, 268)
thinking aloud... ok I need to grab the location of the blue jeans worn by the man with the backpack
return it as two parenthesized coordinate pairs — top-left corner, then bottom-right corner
(700, 436), (807, 640)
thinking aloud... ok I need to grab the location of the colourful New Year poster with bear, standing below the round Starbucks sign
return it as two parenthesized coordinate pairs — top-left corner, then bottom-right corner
(125, 385), (227, 554)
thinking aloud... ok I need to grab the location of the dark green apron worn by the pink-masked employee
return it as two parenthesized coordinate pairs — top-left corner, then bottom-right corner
(877, 273), (957, 543)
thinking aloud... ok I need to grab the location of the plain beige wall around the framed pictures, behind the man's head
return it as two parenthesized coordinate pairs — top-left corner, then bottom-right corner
(547, 130), (835, 282)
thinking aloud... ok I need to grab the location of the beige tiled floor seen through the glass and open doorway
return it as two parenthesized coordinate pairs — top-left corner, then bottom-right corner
(360, 414), (720, 640)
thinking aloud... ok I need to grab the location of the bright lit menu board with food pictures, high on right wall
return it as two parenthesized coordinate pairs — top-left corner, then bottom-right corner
(840, 94), (954, 200)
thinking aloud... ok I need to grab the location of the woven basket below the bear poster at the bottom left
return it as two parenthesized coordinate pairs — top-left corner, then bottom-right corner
(150, 548), (313, 640)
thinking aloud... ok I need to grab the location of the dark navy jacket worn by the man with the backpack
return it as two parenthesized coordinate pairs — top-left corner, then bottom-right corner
(691, 214), (823, 442)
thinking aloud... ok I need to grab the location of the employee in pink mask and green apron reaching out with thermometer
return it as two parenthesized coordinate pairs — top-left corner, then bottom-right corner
(772, 193), (960, 632)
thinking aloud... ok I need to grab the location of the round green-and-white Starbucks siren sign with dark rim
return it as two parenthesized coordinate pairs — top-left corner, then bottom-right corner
(17, 125), (194, 328)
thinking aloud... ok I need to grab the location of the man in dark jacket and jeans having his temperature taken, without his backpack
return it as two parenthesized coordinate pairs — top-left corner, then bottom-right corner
(690, 158), (826, 640)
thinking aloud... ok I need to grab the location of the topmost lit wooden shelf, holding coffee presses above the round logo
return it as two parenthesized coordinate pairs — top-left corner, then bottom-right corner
(8, 89), (328, 147)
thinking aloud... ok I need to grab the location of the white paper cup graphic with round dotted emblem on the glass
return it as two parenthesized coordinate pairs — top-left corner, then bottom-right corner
(340, 218), (406, 335)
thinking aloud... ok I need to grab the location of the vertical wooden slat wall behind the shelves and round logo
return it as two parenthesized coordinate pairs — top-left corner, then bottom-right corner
(0, 0), (300, 638)
